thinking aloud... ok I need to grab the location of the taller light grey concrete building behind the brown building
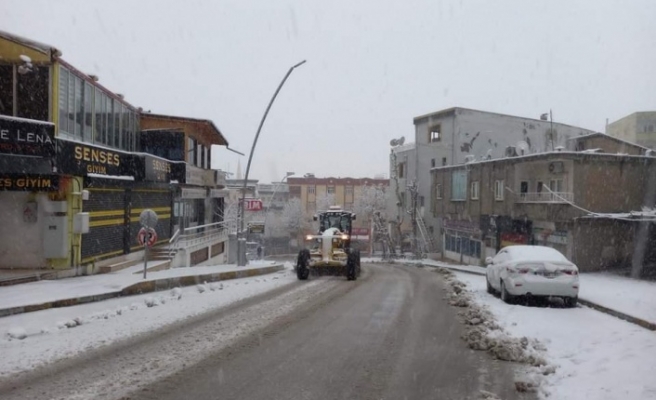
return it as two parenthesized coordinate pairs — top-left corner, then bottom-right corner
(388, 107), (595, 255)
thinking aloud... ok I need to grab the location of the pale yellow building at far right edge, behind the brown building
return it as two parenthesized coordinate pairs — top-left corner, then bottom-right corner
(606, 111), (656, 149)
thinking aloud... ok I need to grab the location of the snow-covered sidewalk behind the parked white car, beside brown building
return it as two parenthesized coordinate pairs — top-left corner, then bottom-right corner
(404, 260), (656, 330)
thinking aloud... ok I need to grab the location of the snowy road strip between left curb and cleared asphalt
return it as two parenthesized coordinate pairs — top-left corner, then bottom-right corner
(0, 265), (296, 378)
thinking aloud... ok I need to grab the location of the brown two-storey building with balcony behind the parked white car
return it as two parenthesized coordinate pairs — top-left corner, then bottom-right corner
(431, 136), (656, 271)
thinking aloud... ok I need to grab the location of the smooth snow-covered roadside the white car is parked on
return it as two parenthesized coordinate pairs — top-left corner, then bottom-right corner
(455, 272), (656, 400)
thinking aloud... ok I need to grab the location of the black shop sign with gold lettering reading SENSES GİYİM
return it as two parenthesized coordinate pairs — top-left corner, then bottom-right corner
(57, 140), (133, 176)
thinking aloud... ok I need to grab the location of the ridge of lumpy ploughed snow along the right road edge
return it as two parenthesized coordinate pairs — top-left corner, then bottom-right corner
(435, 268), (556, 392)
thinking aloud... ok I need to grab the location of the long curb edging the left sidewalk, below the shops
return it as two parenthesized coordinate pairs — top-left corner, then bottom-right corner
(0, 264), (285, 318)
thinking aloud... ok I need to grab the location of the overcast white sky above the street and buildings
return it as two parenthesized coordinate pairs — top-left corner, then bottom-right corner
(0, 0), (656, 181)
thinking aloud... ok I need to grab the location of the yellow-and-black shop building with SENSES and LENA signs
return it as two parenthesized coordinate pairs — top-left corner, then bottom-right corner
(0, 32), (227, 269)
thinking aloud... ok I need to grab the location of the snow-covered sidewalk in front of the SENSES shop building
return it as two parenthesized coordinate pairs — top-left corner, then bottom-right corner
(0, 261), (284, 317)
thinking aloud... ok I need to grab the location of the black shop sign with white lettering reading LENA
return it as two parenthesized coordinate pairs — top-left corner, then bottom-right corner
(0, 116), (55, 157)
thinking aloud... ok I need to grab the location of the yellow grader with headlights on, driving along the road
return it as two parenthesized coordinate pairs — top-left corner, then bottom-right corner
(296, 206), (360, 281)
